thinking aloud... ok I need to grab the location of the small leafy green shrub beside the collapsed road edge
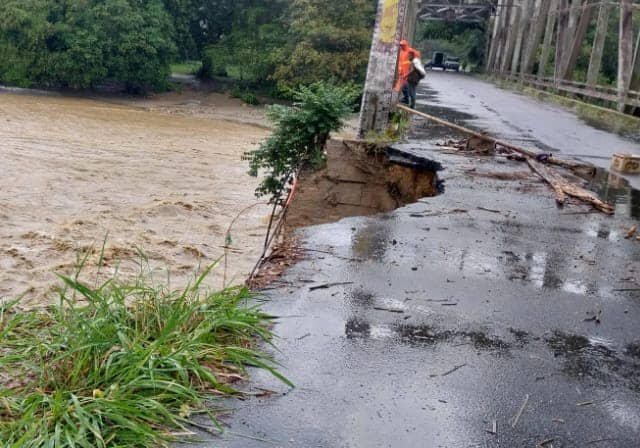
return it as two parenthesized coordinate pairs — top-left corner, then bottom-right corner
(244, 83), (353, 202)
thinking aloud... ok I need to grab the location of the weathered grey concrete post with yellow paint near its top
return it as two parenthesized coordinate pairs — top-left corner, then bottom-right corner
(359, 0), (417, 137)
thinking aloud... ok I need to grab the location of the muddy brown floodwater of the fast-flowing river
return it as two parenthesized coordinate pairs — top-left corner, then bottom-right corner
(0, 92), (269, 306)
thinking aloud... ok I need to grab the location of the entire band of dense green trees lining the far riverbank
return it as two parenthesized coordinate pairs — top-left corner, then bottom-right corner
(0, 0), (377, 95)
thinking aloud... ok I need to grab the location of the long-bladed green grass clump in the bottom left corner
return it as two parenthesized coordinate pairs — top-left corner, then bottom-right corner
(0, 260), (291, 448)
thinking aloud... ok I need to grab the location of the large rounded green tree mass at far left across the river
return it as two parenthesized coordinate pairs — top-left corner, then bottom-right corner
(0, 0), (175, 92)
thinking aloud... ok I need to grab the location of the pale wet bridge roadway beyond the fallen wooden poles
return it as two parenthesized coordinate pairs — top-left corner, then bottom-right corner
(412, 71), (640, 188)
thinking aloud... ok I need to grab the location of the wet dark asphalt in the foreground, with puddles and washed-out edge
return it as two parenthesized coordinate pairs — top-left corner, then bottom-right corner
(185, 75), (640, 448)
